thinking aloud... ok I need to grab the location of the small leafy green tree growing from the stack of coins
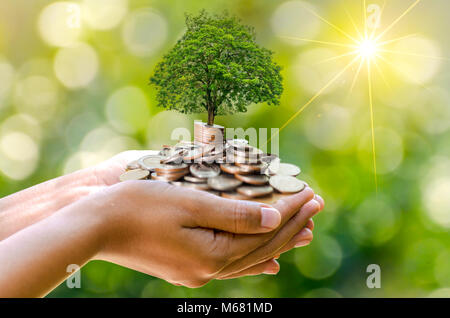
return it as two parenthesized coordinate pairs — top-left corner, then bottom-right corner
(150, 11), (283, 125)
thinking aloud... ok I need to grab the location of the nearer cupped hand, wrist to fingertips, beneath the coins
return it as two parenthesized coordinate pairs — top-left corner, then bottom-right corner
(88, 181), (321, 287)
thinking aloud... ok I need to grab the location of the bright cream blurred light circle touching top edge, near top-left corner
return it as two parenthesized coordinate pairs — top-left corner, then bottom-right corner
(38, 1), (82, 47)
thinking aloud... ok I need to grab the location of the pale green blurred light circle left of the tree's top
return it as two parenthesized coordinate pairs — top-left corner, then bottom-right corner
(122, 8), (168, 57)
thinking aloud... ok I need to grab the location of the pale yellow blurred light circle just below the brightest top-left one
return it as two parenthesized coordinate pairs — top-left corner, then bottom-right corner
(53, 43), (99, 89)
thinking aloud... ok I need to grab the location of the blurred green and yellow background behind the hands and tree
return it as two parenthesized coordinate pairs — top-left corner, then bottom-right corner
(0, 0), (450, 297)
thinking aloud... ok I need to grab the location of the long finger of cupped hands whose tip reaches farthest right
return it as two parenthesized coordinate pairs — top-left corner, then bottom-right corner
(217, 199), (320, 275)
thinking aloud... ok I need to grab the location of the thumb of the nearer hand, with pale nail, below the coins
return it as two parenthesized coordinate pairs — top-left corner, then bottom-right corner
(195, 196), (281, 234)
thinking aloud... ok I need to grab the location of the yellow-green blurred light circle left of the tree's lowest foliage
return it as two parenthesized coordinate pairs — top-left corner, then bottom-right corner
(105, 86), (149, 134)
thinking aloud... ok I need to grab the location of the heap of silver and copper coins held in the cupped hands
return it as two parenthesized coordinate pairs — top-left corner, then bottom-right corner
(120, 125), (305, 203)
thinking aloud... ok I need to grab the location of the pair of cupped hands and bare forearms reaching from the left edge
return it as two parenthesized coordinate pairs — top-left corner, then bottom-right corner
(0, 151), (323, 297)
